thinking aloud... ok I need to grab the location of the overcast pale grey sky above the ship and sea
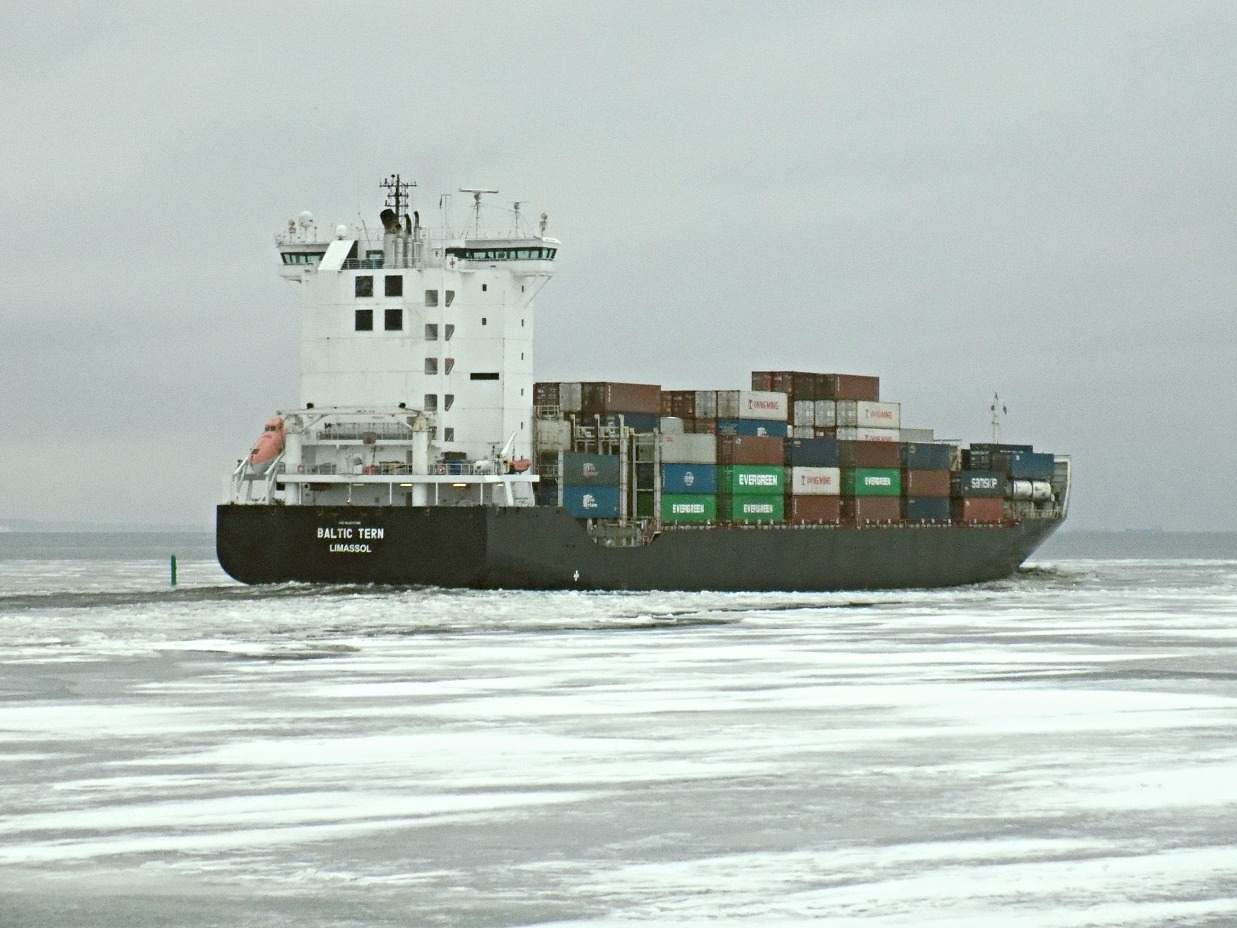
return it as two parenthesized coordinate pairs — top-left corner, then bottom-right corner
(0, 0), (1237, 530)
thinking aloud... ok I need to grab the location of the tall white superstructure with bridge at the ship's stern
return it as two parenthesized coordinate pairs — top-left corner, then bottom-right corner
(229, 174), (559, 505)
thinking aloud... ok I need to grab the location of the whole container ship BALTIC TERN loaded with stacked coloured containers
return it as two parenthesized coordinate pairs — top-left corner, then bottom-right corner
(215, 174), (1071, 591)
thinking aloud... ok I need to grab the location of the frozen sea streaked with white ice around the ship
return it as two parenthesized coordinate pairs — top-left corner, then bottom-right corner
(0, 532), (1237, 928)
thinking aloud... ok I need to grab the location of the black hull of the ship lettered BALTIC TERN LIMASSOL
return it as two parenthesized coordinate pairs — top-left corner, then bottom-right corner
(215, 505), (1060, 591)
